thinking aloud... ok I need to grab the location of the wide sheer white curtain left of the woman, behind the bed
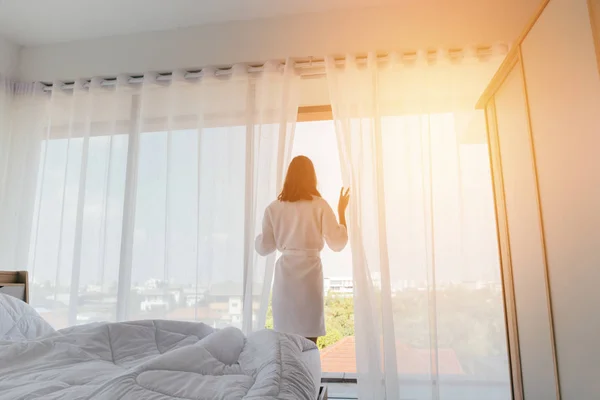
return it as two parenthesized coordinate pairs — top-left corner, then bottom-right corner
(1, 62), (297, 331)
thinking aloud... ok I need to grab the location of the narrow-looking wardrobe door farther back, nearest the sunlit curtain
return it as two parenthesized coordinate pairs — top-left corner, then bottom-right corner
(494, 63), (556, 399)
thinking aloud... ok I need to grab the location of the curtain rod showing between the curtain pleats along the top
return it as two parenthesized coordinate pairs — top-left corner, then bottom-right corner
(41, 43), (508, 92)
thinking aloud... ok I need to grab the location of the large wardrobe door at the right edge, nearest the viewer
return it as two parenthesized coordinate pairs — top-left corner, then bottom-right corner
(521, 0), (600, 400)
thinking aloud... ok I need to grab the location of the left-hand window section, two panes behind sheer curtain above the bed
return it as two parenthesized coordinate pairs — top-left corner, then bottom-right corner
(30, 126), (246, 328)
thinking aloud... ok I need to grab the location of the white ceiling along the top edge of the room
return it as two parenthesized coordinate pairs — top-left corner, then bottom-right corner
(0, 0), (408, 46)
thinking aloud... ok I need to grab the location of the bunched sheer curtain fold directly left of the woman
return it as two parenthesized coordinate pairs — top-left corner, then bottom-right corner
(244, 60), (299, 331)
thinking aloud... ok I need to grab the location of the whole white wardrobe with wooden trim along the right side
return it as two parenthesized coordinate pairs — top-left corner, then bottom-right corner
(478, 0), (600, 400)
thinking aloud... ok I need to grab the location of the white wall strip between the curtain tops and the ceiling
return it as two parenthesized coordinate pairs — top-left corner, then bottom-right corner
(19, 0), (537, 81)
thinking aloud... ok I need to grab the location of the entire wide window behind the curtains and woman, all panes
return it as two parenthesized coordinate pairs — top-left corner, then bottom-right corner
(31, 104), (510, 399)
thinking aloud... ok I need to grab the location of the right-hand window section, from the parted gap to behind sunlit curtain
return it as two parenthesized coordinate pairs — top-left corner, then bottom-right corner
(293, 110), (510, 399)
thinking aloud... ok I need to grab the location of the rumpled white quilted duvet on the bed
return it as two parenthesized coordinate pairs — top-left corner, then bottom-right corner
(0, 294), (316, 400)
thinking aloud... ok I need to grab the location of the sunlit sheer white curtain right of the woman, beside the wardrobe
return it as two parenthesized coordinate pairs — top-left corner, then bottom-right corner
(326, 47), (510, 400)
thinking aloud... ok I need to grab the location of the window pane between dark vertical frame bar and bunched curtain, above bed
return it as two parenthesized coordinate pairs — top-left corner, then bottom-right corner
(129, 126), (246, 328)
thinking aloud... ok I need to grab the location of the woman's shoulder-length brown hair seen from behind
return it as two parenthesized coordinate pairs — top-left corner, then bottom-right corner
(277, 156), (321, 202)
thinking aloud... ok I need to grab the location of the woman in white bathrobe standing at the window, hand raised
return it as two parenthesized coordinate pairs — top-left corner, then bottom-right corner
(255, 156), (350, 343)
